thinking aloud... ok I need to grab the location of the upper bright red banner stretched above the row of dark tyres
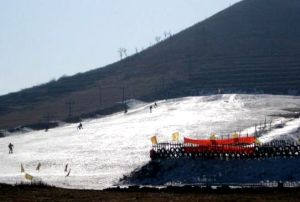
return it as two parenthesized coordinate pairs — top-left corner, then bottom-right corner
(184, 137), (256, 146)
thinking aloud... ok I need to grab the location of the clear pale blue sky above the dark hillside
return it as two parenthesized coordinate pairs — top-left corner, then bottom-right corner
(0, 0), (240, 95)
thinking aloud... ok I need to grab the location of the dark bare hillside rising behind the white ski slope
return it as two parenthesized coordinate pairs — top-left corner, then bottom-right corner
(0, 0), (300, 128)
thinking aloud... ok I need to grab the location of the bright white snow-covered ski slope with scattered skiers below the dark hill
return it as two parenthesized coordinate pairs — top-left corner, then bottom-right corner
(0, 94), (300, 189)
